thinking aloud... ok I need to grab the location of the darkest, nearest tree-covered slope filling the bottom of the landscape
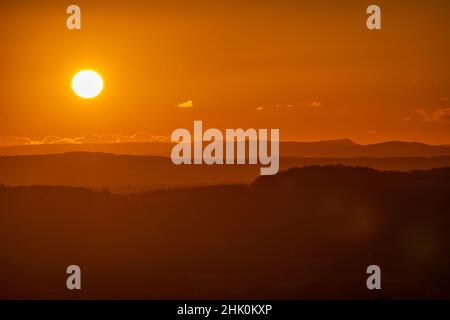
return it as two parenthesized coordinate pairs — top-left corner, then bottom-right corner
(0, 167), (450, 299)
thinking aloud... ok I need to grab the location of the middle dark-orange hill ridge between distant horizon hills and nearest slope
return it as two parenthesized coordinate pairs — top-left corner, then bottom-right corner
(0, 152), (450, 192)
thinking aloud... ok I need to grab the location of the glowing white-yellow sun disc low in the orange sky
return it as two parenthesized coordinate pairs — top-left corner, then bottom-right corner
(72, 70), (103, 99)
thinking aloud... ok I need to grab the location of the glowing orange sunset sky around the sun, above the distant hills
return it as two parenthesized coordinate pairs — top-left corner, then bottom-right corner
(0, 0), (450, 144)
